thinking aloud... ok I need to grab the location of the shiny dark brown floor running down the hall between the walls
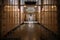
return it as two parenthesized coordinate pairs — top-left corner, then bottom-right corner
(2, 22), (57, 40)
